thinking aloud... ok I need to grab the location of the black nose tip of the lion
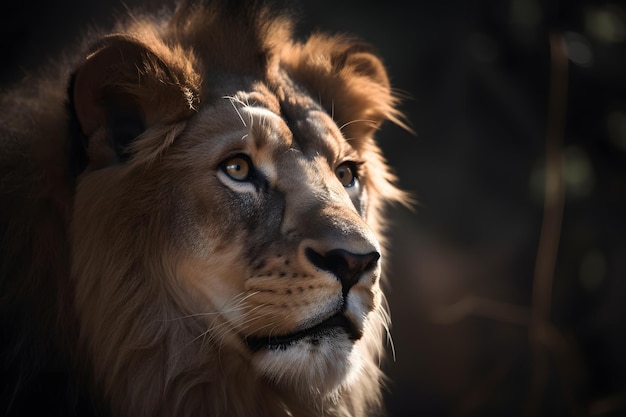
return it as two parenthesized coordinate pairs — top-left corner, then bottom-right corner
(305, 248), (380, 295)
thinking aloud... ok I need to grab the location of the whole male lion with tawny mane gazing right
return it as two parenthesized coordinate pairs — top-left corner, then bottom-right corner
(0, 1), (406, 417)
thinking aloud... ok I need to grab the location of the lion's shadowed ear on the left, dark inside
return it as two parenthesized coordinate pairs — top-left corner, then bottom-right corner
(70, 35), (194, 167)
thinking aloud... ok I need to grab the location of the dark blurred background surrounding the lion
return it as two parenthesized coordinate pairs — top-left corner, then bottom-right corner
(0, 0), (626, 417)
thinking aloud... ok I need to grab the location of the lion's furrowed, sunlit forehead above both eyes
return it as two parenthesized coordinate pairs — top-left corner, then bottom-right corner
(192, 89), (356, 177)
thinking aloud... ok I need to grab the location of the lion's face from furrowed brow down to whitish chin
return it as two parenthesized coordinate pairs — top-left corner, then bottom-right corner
(173, 86), (381, 391)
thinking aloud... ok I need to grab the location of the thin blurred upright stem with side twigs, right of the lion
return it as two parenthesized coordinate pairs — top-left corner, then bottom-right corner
(424, 30), (584, 417)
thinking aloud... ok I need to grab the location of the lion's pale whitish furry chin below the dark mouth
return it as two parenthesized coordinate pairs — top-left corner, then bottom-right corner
(246, 327), (361, 395)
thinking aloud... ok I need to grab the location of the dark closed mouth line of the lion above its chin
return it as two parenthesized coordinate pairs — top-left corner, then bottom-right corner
(246, 313), (362, 353)
